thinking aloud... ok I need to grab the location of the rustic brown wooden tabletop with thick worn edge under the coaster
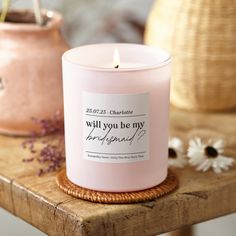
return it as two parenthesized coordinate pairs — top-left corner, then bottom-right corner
(0, 109), (236, 236)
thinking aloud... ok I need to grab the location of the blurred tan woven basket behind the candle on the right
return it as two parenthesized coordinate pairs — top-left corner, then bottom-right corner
(145, 0), (236, 111)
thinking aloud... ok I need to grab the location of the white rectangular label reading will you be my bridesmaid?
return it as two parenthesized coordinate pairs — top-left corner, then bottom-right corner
(82, 92), (149, 163)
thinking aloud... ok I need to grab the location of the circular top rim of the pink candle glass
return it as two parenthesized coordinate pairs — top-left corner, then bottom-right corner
(62, 43), (172, 73)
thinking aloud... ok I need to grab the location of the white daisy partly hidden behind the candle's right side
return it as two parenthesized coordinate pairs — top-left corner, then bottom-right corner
(168, 137), (187, 168)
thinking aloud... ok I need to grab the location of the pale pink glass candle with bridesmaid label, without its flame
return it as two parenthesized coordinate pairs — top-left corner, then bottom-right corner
(62, 44), (170, 192)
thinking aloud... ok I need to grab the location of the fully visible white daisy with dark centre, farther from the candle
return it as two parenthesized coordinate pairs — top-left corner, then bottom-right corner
(187, 138), (234, 173)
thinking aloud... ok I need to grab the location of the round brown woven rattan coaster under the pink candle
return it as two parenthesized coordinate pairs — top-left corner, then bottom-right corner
(56, 169), (178, 203)
